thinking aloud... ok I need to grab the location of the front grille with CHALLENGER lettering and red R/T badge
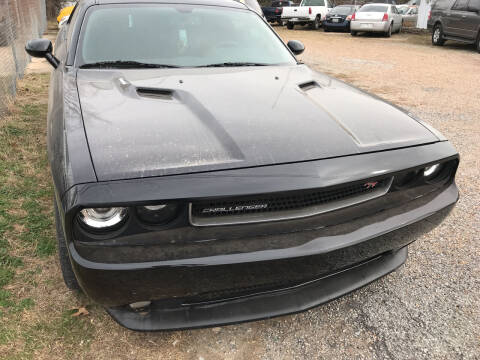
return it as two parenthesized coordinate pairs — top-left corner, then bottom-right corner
(190, 178), (392, 226)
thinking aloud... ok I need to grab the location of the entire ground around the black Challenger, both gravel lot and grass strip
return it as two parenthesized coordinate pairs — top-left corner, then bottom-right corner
(0, 28), (480, 359)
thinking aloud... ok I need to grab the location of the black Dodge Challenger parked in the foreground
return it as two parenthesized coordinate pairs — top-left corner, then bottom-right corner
(26, 0), (459, 330)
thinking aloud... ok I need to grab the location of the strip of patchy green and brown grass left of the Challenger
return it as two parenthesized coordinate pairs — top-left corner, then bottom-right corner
(0, 74), (98, 359)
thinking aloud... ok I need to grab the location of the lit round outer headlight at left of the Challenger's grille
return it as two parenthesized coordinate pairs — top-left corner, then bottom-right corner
(78, 207), (127, 230)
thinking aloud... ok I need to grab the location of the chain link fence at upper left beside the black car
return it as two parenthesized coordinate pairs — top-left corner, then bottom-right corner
(0, 0), (47, 115)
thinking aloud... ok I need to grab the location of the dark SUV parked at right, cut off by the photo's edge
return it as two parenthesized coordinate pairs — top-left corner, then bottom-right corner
(428, 0), (480, 52)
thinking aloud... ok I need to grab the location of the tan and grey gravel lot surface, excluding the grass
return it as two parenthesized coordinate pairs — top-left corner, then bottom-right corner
(15, 28), (480, 360)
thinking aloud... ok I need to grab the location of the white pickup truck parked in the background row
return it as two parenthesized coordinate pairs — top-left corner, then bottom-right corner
(282, 0), (333, 29)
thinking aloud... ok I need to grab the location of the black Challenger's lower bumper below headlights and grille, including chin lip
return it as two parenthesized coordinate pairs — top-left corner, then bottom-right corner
(70, 183), (458, 330)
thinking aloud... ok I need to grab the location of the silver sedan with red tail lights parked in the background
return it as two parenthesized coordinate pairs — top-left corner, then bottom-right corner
(350, 4), (403, 37)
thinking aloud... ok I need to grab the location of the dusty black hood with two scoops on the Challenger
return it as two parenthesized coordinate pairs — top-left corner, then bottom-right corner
(77, 65), (438, 181)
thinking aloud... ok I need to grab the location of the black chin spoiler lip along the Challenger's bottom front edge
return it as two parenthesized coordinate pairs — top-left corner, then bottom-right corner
(107, 247), (407, 331)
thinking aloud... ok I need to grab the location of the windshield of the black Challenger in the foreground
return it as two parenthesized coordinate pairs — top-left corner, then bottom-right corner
(77, 4), (296, 67)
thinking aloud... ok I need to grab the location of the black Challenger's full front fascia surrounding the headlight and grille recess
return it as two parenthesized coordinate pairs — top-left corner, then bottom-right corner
(63, 142), (458, 330)
